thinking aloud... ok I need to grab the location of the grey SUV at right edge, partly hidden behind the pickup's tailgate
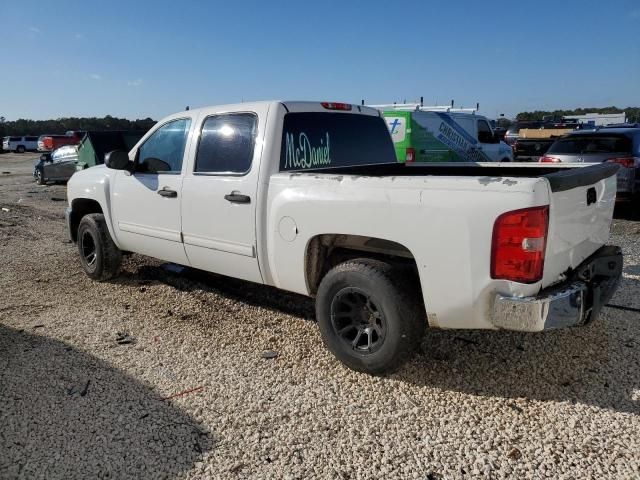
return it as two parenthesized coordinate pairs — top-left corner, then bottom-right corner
(540, 127), (640, 202)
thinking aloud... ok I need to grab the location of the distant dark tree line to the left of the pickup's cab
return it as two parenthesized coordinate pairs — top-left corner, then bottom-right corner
(0, 115), (156, 137)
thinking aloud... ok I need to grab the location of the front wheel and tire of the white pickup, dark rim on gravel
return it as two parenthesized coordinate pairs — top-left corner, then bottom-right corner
(78, 213), (122, 281)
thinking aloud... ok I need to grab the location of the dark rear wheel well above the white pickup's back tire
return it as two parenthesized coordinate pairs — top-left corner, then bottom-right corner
(305, 234), (421, 295)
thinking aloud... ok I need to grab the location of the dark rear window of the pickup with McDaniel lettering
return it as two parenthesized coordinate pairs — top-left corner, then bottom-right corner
(280, 112), (397, 171)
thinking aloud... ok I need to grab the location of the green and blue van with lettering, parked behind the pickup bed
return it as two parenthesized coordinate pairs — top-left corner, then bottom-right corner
(378, 105), (513, 163)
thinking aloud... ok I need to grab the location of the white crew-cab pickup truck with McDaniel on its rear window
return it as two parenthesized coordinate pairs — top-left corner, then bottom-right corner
(66, 101), (622, 373)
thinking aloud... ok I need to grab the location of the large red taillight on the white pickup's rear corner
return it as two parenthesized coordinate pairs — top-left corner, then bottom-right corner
(491, 205), (549, 283)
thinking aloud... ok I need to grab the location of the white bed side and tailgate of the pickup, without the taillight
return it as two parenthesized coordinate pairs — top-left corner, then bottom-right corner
(265, 159), (615, 330)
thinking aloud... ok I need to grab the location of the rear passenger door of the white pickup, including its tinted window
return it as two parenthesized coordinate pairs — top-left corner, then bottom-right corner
(182, 106), (268, 283)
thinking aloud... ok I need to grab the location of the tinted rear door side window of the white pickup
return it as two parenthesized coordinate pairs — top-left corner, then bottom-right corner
(195, 113), (257, 174)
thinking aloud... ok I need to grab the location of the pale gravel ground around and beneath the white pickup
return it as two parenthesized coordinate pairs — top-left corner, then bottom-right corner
(0, 154), (640, 480)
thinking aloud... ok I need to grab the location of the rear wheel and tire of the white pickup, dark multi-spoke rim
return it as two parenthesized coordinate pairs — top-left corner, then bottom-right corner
(316, 258), (426, 375)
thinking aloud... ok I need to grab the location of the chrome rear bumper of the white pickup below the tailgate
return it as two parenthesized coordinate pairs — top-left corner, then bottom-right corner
(491, 246), (622, 332)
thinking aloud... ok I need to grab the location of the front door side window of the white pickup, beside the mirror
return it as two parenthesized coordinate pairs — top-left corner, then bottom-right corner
(136, 118), (191, 173)
